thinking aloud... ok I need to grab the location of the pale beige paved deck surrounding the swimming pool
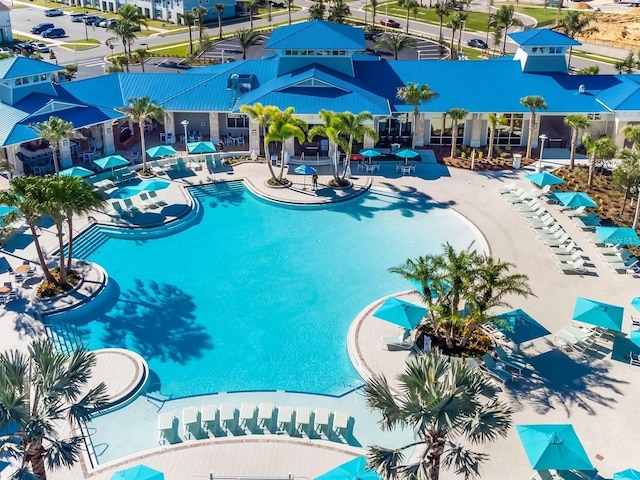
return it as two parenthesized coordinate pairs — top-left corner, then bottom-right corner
(0, 160), (640, 480)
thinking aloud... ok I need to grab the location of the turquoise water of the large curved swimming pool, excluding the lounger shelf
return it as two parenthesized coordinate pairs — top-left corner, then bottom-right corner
(52, 183), (484, 397)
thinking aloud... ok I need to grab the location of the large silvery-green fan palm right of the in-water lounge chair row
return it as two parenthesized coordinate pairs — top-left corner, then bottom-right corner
(364, 350), (511, 480)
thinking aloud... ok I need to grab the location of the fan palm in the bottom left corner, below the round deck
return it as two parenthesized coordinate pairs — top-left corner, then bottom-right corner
(0, 338), (108, 480)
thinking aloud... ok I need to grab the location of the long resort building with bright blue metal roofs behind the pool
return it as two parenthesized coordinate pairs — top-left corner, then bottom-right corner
(0, 20), (640, 173)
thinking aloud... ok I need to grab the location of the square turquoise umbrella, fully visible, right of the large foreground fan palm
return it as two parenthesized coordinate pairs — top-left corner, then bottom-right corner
(516, 424), (593, 470)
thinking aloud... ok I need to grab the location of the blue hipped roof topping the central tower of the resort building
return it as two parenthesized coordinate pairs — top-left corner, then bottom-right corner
(264, 20), (366, 50)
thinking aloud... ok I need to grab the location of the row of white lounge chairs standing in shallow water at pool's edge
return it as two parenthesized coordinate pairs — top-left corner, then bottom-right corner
(158, 402), (351, 445)
